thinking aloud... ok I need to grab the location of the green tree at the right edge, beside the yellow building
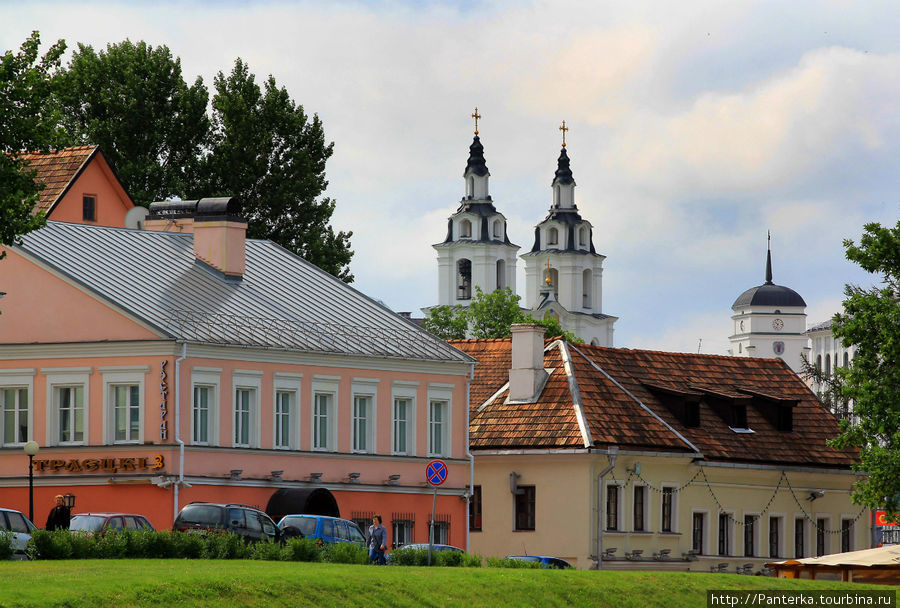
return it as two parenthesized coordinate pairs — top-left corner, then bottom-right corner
(832, 222), (900, 513)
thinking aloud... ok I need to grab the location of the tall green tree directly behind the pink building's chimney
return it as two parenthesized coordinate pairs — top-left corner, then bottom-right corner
(194, 59), (353, 283)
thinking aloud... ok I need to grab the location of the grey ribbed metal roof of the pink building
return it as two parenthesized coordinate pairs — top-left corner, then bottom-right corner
(17, 221), (472, 363)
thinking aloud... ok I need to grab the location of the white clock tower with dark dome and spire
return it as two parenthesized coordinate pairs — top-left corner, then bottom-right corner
(729, 237), (809, 373)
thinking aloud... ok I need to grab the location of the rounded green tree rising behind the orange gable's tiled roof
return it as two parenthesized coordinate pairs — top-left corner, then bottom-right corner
(56, 40), (209, 206)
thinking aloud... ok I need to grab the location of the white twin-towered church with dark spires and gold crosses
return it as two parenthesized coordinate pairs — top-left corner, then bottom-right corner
(433, 121), (617, 346)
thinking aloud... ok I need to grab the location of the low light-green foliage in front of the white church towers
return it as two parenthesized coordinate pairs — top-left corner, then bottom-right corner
(424, 286), (584, 344)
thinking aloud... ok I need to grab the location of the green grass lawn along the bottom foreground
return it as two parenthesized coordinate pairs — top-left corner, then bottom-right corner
(0, 560), (896, 608)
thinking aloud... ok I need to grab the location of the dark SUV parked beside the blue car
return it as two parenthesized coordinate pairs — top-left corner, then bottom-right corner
(172, 502), (281, 541)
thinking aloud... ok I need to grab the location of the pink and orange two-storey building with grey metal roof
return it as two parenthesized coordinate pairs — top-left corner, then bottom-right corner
(0, 199), (474, 546)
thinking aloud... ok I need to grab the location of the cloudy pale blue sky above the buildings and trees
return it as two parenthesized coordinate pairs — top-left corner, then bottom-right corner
(0, 0), (900, 354)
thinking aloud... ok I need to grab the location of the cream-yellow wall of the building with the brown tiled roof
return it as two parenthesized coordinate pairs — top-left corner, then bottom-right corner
(470, 452), (870, 572)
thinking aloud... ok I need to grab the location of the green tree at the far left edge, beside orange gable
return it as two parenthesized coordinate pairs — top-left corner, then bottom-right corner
(0, 31), (66, 258)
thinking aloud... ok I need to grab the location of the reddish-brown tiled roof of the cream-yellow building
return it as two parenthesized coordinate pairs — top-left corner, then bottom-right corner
(451, 339), (855, 469)
